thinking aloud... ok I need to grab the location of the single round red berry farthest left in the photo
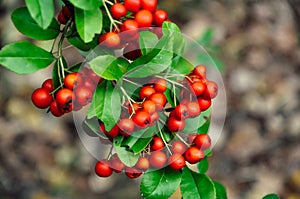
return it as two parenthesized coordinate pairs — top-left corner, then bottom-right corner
(31, 88), (52, 109)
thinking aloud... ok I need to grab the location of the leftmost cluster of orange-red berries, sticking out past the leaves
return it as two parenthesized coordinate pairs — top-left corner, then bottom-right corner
(31, 67), (102, 117)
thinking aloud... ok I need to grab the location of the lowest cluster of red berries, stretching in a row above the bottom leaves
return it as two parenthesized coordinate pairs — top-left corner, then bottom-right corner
(95, 134), (211, 178)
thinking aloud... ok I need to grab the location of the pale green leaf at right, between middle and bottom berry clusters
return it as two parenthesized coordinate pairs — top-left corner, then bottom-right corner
(182, 108), (211, 133)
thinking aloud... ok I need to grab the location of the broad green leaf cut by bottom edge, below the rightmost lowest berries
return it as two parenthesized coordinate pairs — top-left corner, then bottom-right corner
(180, 167), (216, 199)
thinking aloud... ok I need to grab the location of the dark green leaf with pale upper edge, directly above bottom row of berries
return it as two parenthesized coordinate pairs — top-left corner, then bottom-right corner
(122, 126), (157, 154)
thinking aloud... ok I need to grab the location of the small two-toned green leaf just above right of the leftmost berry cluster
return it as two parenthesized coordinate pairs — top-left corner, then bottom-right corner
(89, 55), (128, 80)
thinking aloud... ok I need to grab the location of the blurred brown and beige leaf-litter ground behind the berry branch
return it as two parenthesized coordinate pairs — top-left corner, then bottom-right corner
(0, 0), (300, 199)
